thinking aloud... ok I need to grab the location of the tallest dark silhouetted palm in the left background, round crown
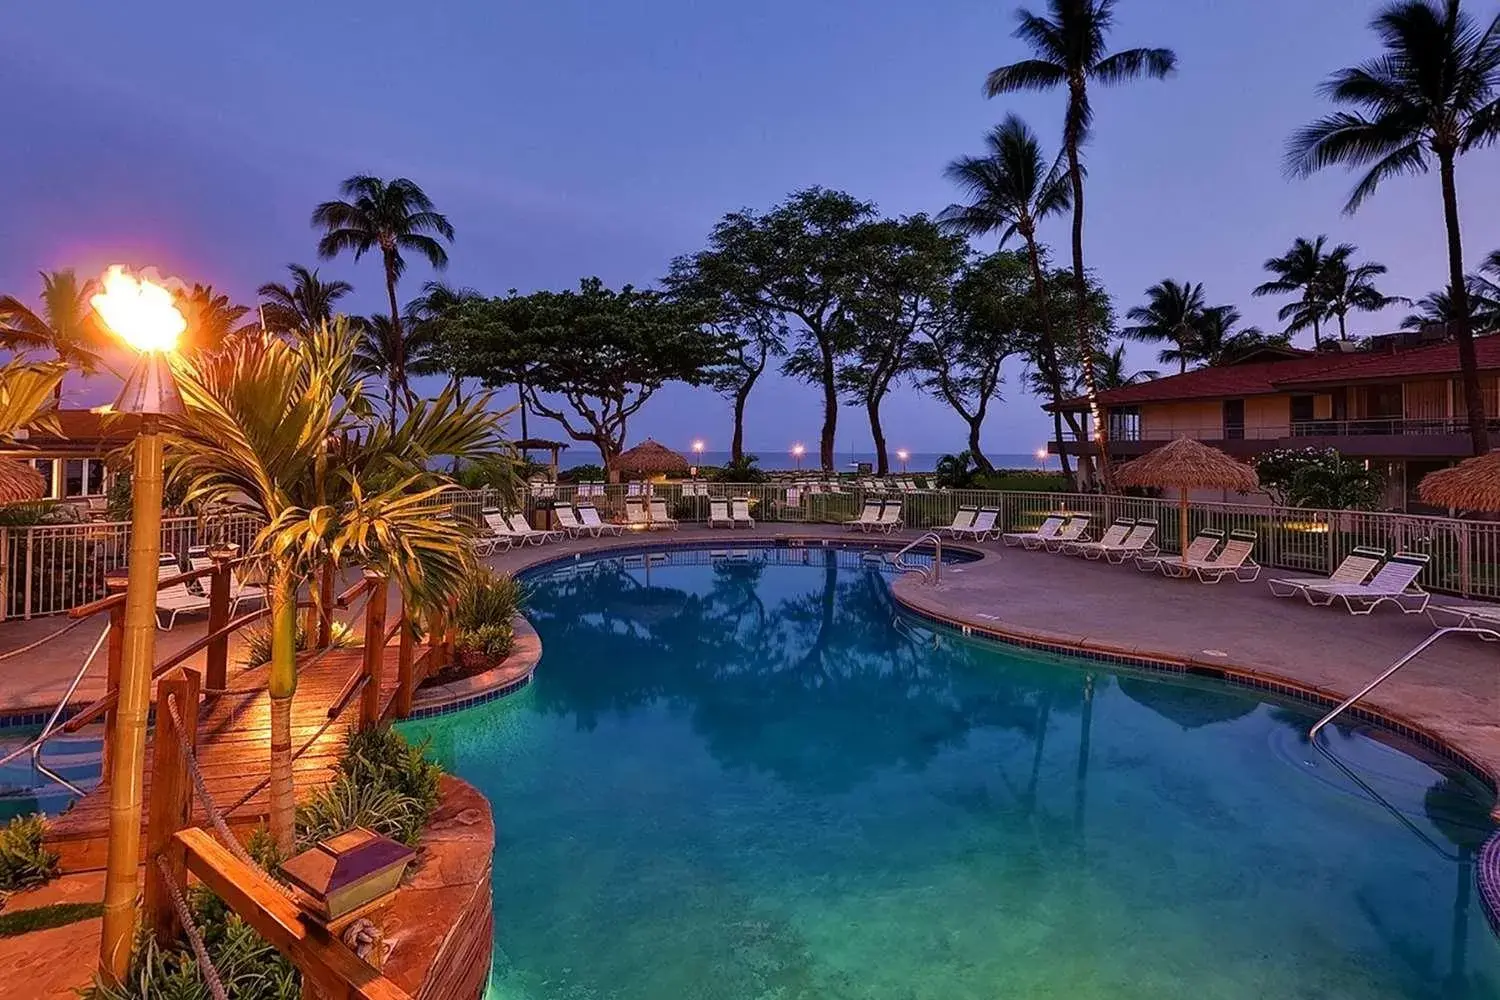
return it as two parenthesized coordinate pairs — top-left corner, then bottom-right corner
(312, 174), (453, 422)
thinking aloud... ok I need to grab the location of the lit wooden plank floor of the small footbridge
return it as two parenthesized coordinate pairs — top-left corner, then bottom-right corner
(47, 643), (408, 873)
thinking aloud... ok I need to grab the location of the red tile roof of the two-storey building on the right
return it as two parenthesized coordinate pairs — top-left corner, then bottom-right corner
(1064, 336), (1500, 409)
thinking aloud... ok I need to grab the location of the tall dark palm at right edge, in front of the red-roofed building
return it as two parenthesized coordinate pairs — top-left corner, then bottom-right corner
(1287, 0), (1500, 454)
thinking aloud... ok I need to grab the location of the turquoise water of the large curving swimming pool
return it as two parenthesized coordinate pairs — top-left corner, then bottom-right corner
(405, 550), (1500, 1000)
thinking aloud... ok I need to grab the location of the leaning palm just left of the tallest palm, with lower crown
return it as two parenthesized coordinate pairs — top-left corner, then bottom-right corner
(938, 114), (1073, 480)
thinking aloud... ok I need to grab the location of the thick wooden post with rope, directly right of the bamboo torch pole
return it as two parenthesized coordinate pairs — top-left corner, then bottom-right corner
(143, 670), (201, 945)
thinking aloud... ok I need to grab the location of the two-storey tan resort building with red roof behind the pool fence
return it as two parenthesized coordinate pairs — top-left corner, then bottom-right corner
(1049, 334), (1500, 511)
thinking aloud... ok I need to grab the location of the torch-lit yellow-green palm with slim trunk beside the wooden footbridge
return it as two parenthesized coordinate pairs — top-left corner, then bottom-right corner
(165, 322), (500, 852)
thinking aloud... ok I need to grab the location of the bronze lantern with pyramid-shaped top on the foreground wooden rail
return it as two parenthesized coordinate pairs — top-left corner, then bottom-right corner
(282, 826), (417, 924)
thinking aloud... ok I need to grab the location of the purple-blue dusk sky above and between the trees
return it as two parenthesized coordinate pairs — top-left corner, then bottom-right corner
(0, 0), (1500, 457)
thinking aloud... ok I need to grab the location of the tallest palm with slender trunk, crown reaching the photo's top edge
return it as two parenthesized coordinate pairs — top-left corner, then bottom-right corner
(984, 0), (1178, 490)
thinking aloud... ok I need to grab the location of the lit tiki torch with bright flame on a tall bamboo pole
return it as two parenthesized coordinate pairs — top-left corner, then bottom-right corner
(90, 267), (187, 984)
